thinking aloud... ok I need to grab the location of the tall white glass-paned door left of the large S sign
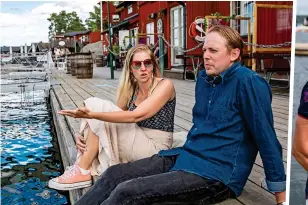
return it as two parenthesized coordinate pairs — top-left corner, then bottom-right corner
(170, 6), (184, 66)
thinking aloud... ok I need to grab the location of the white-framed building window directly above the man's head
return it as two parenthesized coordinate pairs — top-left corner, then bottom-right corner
(230, 1), (255, 36)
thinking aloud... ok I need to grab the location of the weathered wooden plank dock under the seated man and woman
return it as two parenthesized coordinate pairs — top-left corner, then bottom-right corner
(50, 67), (289, 205)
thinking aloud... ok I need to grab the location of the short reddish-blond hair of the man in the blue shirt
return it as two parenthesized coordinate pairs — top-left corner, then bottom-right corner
(207, 25), (244, 61)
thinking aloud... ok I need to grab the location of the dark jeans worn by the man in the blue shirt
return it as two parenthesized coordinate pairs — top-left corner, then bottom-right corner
(76, 155), (235, 205)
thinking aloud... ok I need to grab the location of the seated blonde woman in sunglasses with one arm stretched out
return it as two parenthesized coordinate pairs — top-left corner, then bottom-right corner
(48, 44), (175, 190)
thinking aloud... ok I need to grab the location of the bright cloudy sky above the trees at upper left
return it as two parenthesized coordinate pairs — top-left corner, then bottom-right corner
(0, 0), (99, 46)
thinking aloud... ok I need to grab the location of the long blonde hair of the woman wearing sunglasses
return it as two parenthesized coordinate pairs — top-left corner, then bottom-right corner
(117, 44), (160, 108)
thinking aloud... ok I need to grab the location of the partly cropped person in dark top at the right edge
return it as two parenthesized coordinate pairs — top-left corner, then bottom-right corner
(292, 82), (308, 204)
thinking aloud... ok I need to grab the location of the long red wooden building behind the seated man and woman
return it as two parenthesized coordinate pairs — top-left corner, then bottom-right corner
(97, 1), (293, 73)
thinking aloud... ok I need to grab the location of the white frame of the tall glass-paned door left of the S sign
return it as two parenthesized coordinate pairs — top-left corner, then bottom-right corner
(170, 6), (184, 66)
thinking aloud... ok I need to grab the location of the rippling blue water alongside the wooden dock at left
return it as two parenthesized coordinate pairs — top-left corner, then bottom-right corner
(1, 53), (69, 205)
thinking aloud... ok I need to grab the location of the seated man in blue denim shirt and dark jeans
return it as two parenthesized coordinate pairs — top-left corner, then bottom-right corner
(77, 26), (286, 205)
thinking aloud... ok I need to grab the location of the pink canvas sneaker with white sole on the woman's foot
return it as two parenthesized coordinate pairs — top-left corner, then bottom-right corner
(48, 165), (92, 190)
